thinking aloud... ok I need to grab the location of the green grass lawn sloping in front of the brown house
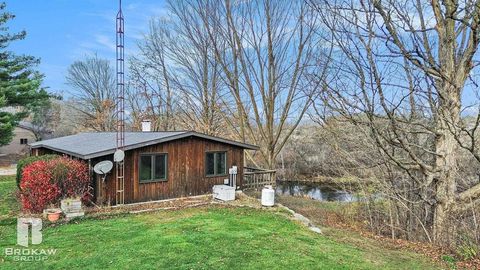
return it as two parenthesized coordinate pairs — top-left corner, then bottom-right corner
(0, 176), (437, 269)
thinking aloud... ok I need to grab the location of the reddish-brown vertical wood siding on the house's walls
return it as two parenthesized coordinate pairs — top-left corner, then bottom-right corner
(32, 137), (244, 204)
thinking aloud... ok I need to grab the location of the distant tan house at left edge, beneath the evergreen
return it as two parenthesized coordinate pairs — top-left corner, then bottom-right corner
(0, 121), (51, 166)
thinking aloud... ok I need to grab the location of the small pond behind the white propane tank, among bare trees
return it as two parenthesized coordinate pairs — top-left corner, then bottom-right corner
(275, 181), (359, 202)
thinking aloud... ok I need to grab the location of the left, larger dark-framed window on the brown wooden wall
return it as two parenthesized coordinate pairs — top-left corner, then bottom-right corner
(139, 154), (168, 183)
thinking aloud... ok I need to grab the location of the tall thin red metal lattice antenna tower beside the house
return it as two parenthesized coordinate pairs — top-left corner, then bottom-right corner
(115, 0), (125, 204)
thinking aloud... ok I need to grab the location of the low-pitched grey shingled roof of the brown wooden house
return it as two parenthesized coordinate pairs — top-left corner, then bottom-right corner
(30, 131), (258, 159)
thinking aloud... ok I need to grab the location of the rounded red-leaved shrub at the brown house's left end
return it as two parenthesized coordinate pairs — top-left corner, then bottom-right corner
(20, 157), (90, 213)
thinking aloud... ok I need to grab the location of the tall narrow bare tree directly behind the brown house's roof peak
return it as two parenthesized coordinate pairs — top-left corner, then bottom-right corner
(168, 1), (226, 135)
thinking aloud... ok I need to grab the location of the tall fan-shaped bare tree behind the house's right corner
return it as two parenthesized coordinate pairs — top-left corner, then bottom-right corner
(197, 0), (325, 168)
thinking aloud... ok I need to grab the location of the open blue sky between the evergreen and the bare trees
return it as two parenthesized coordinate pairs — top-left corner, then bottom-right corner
(6, 0), (166, 96)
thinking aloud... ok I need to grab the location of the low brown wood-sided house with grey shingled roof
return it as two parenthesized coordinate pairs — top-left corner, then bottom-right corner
(30, 131), (258, 204)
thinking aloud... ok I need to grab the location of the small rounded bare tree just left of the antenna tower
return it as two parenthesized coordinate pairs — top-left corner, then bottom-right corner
(66, 55), (115, 131)
